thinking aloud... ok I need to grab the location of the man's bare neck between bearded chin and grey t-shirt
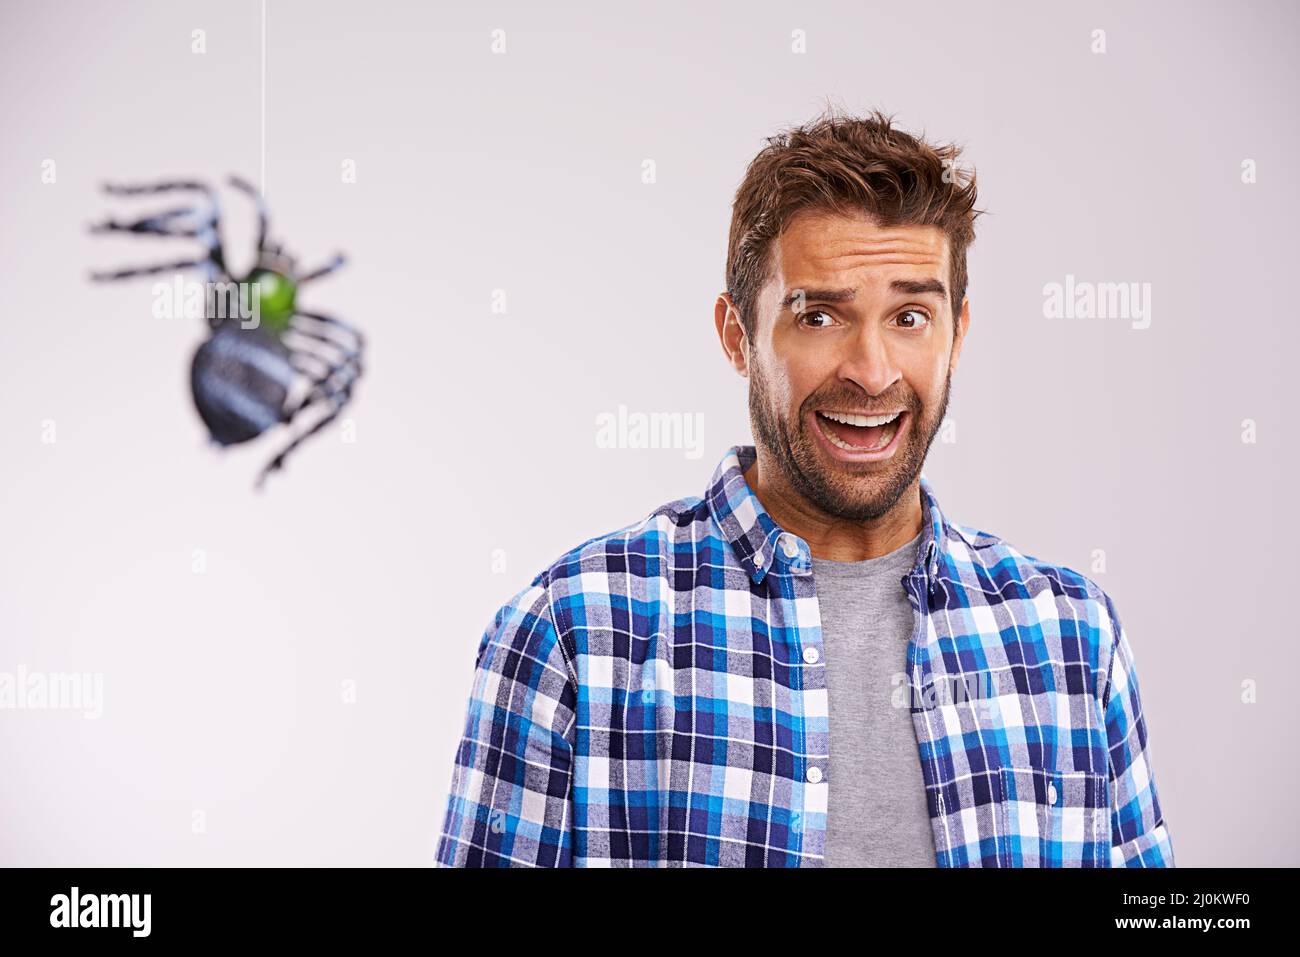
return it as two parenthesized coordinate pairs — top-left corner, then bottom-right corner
(744, 455), (922, 562)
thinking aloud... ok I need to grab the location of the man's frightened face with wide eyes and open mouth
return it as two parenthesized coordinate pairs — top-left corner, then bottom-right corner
(748, 212), (969, 523)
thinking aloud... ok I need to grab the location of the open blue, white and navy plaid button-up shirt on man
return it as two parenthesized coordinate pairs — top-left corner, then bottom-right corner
(436, 446), (1174, 867)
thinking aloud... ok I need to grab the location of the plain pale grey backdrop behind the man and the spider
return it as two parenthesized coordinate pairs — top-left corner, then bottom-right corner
(0, 0), (1300, 866)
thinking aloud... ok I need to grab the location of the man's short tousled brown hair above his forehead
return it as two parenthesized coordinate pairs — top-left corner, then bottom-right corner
(727, 108), (983, 338)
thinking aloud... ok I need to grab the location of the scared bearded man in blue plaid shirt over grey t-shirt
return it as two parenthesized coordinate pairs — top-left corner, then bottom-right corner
(437, 113), (1174, 867)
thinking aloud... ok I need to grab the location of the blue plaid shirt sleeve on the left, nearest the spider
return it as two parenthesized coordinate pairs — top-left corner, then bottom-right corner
(434, 576), (577, 867)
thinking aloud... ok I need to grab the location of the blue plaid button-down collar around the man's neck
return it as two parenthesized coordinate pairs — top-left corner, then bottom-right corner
(705, 445), (948, 594)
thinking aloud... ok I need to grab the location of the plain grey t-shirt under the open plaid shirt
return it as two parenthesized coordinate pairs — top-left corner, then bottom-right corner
(813, 534), (937, 867)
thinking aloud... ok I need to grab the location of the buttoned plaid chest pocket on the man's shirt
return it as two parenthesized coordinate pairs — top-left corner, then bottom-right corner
(998, 765), (1110, 867)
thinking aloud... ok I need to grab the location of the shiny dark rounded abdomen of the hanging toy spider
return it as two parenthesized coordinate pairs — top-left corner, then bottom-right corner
(190, 320), (296, 445)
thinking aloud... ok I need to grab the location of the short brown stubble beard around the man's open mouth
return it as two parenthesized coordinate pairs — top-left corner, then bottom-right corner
(749, 356), (953, 521)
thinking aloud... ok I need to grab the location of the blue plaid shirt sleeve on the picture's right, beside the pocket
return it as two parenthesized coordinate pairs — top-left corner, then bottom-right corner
(1101, 596), (1174, 867)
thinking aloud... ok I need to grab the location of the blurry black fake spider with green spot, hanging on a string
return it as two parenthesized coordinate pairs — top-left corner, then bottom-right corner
(91, 177), (365, 488)
